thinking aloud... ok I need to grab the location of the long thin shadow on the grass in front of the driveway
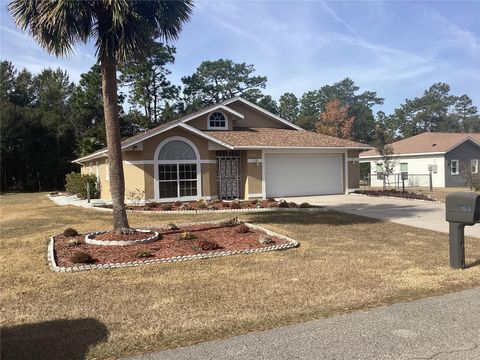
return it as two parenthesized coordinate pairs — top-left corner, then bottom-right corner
(249, 211), (383, 225)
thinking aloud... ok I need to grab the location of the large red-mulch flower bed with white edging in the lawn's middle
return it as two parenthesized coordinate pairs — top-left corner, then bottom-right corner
(49, 221), (298, 271)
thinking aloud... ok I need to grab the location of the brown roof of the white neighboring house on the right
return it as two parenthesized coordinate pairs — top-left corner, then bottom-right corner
(360, 132), (480, 157)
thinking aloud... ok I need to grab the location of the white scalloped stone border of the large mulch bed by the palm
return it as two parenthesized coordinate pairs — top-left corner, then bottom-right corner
(47, 220), (299, 272)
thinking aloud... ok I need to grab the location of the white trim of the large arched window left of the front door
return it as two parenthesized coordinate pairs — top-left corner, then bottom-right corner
(153, 136), (202, 202)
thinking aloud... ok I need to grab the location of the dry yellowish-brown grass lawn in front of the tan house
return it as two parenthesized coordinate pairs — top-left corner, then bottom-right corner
(0, 194), (480, 359)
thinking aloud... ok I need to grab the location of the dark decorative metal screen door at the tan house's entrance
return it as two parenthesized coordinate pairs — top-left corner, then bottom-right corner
(217, 151), (241, 199)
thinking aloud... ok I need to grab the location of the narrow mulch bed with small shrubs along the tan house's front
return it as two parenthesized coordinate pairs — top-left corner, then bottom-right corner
(98, 199), (317, 211)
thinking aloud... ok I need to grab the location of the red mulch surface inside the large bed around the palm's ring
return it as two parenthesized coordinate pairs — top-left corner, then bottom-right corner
(55, 224), (286, 266)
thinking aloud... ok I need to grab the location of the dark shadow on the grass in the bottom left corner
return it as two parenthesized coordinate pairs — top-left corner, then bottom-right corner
(0, 318), (108, 360)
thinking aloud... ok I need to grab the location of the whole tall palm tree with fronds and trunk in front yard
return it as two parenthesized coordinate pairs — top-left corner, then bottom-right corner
(9, 0), (193, 233)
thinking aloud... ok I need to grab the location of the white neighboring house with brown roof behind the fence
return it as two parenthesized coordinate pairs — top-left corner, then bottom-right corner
(360, 132), (480, 187)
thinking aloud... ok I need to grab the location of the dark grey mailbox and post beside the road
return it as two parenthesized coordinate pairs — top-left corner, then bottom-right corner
(445, 193), (480, 269)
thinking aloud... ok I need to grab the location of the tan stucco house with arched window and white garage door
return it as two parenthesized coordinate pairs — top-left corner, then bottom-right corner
(74, 97), (371, 202)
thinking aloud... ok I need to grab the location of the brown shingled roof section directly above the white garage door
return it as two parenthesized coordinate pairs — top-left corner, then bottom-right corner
(204, 128), (371, 149)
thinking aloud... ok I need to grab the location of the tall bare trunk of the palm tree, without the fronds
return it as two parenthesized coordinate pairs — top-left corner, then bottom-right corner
(101, 54), (132, 233)
